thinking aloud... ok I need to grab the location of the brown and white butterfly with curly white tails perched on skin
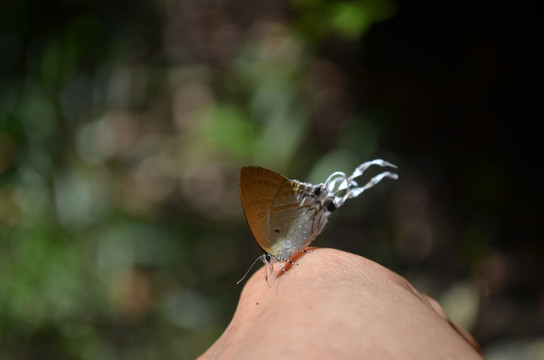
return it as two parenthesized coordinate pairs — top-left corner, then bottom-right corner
(237, 159), (398, 284)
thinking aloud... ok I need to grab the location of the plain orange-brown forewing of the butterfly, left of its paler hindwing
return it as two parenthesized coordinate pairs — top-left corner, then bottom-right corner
(240, 166), (289, 254)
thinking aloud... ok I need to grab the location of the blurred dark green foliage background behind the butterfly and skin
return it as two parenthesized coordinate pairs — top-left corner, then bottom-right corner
(0, 0), (544, 359)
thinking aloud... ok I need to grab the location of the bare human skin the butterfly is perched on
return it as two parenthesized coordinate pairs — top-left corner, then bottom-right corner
(200, 249), (482, 360)
